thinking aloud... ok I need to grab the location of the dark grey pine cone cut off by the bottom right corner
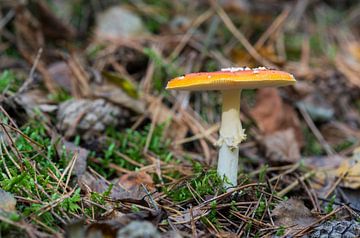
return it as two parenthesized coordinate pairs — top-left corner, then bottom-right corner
(310, 220), (360, 238)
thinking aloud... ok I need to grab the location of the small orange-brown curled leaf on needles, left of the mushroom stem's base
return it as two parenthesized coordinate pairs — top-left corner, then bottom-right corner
(117, 171), (155, 191)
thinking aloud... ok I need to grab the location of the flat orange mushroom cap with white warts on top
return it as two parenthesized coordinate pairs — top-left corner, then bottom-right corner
(166, 67), (296, 91)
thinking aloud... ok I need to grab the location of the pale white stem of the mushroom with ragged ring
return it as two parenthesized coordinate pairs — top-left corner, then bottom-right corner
(217, 89), (246, 188)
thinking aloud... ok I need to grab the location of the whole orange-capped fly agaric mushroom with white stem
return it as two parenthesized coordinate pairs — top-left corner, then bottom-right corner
(166, 67), (296, 188)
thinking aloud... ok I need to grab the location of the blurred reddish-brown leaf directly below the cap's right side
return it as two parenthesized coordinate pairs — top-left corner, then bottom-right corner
(250, 88), (304, 146)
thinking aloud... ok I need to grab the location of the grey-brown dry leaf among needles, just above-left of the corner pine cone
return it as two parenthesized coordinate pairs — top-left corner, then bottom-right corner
(272, 198), (317, 234)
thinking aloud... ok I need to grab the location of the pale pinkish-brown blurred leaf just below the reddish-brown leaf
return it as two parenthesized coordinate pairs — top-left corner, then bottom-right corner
(260, 128), (301, 163)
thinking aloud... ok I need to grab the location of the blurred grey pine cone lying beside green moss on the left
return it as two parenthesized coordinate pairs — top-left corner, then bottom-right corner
(57, 99), (130, 140)
